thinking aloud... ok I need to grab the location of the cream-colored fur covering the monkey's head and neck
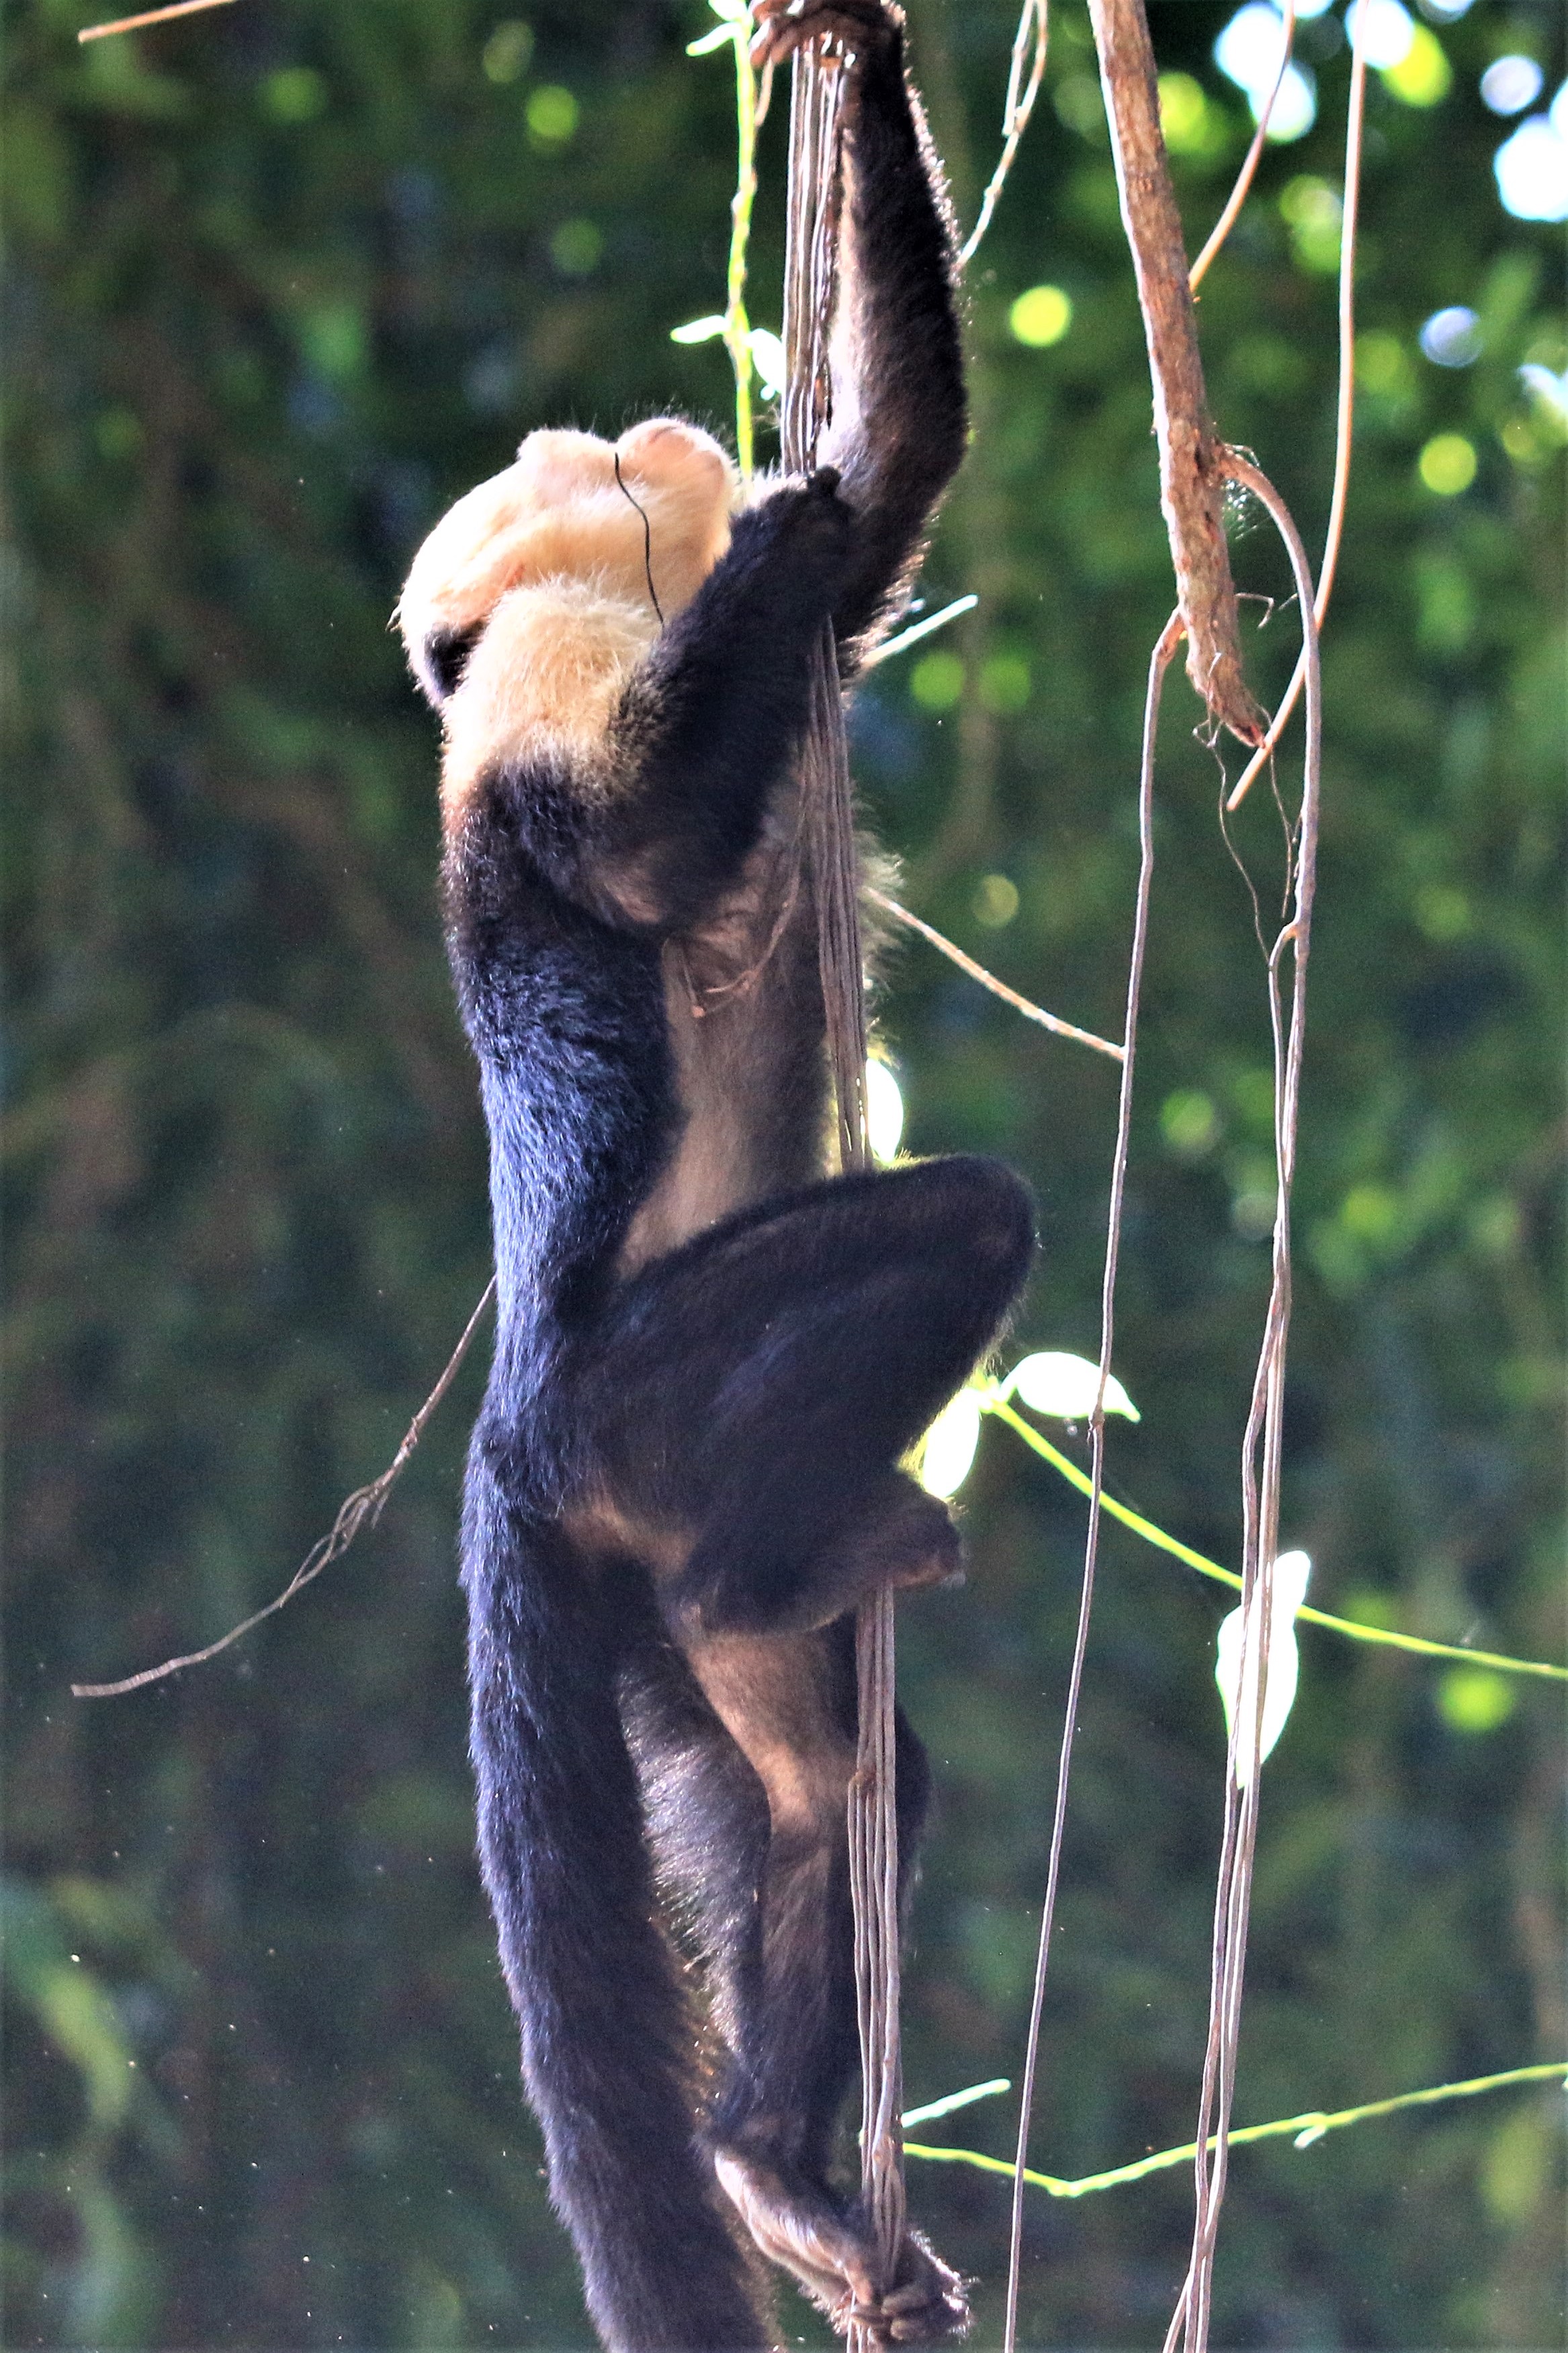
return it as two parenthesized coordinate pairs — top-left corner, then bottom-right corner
(398, 417), (739, 826)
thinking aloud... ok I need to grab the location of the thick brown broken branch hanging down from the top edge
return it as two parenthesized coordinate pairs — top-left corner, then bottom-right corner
(1090, 0), (1262, 744)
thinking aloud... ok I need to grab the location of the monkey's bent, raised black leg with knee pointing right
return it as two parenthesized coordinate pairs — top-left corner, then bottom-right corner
(582, 1160), (1033, 1637)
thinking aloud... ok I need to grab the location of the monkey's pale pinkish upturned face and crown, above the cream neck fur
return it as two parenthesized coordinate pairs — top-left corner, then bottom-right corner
(398, 417), (737, 706)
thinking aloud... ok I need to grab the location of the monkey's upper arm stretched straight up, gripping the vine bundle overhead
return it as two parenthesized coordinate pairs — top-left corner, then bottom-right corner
(756, 0), (967, 669)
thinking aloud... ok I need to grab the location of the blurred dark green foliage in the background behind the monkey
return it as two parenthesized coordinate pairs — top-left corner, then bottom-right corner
(0, 0), (1568, 2348)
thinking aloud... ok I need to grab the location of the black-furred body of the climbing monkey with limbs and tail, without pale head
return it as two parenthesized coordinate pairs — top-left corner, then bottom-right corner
(405, 0), (1031, 2353)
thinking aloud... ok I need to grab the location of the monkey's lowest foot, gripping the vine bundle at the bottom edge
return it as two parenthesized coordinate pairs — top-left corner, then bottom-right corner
(713, 2151), (970, 2346)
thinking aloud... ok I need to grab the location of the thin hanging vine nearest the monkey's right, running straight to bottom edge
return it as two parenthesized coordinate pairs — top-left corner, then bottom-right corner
(1003, 612), (1182, 2353)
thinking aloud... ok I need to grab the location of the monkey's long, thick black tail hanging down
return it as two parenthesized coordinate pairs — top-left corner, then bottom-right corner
(464, 1433), (772, 2353)
